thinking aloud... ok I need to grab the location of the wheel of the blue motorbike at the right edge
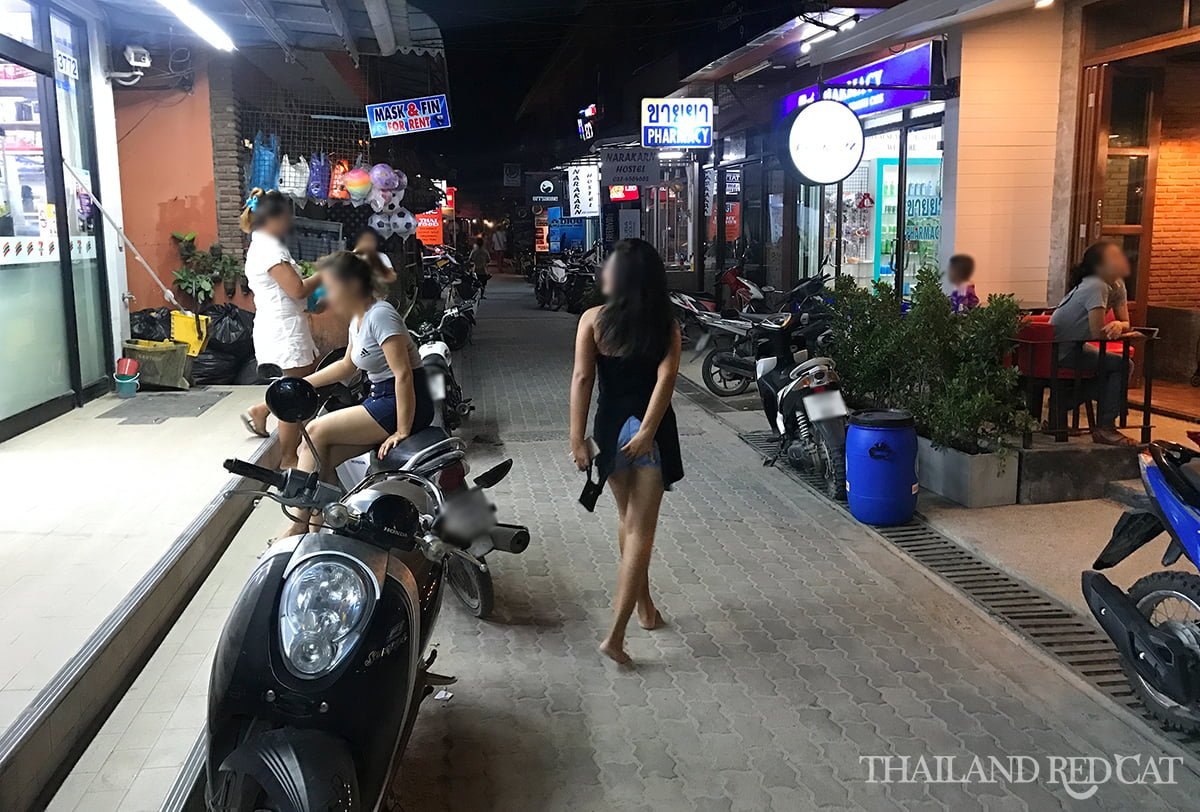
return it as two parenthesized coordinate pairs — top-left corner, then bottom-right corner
(1121, 572), (1200, 733)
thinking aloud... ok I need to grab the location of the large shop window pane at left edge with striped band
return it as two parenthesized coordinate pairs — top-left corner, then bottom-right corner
(0, 60), (71, 420)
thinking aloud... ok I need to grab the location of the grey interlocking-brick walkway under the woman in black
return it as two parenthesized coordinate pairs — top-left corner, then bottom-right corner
(402, 279), (1200, 812)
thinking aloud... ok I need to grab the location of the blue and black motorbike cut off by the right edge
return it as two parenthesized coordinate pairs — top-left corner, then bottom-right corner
(1082, 440), (1200, 734)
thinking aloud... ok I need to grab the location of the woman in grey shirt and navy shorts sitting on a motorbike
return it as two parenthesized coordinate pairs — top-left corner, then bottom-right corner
(290, 251), (433, 534)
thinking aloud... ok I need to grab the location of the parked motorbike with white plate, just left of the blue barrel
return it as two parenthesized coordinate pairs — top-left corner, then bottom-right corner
(756, 313), (850, 499)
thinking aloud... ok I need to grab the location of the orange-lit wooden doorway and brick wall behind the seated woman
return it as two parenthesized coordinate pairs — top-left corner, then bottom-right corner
(1070, 0), (1200, 419)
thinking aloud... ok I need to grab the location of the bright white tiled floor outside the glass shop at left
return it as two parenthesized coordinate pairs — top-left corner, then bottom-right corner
(0, 386), (262, 734)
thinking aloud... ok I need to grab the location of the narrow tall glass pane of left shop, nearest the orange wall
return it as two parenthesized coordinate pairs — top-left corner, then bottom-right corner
(50, 14), (108, 386)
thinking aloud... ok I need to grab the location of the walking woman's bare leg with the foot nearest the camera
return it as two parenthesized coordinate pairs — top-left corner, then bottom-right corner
(600, 468), (662, 663)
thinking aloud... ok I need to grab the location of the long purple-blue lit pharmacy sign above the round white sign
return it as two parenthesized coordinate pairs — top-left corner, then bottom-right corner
(782, 42), (934, 115)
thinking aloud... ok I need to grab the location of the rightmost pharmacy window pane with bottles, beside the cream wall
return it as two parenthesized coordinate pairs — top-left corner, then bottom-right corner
(904, 127), (942, 296)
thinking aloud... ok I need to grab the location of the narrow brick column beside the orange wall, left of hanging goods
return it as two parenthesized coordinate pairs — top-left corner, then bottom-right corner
(209, 55), (245, 258)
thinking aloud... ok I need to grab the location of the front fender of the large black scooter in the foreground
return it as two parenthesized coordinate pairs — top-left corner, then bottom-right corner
(209, 728), (366, 812)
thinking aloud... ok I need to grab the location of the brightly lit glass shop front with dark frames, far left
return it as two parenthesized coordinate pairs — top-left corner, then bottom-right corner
(0, 0), (118, 440)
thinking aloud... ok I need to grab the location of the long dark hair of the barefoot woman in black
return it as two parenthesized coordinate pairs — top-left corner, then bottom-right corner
(596, 240), (674, 361)
